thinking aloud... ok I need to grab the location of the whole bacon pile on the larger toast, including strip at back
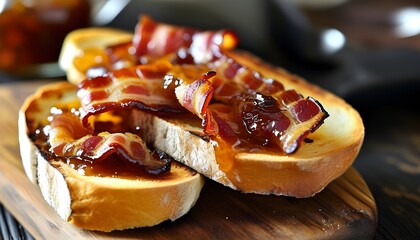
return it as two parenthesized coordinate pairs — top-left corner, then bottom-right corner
(78, 16), (328, 153)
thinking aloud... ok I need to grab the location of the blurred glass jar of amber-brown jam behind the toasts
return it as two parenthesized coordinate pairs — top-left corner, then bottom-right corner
(0, 0), (90, 75)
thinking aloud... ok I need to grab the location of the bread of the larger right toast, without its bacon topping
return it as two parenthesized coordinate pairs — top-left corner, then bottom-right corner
(132, 52), (364, 198)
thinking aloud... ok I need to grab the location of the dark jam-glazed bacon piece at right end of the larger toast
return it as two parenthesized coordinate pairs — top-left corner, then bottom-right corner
(236, 93), (328, 154)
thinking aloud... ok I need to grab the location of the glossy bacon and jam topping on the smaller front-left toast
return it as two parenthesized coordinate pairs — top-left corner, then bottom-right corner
(30, 98), (173, 179)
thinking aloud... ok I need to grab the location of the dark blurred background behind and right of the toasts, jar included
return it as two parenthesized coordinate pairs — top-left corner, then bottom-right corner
(0, 0), (420, 239)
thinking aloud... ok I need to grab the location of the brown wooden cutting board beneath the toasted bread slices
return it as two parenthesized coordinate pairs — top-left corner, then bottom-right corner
(0, 81), (377, 239)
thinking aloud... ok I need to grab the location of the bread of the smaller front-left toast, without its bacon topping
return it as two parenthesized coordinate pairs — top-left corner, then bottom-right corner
(18, 82), (204, 232)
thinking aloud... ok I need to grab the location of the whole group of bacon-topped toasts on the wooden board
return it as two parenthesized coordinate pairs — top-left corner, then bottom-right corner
(19, 16), (364, 231)
